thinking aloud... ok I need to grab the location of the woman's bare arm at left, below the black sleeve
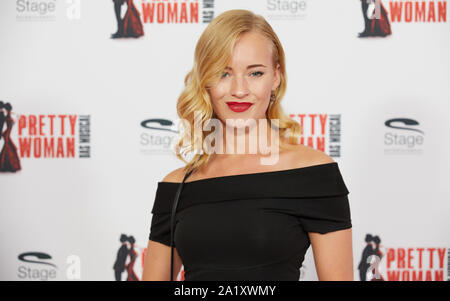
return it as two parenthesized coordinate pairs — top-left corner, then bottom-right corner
(142, 240), (183, 281)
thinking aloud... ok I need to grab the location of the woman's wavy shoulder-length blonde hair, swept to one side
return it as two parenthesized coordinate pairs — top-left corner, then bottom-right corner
(175, 9), (300, 172)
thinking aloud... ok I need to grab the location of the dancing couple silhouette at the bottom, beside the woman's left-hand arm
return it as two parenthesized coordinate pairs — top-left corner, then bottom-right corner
(113, 234), (139, 281)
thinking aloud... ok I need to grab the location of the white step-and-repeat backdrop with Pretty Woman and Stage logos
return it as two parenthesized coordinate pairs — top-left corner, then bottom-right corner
(0, 0), (450, 281)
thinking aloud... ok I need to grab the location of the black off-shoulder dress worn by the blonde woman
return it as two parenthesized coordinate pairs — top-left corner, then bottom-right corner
(149, 162), (352, 281)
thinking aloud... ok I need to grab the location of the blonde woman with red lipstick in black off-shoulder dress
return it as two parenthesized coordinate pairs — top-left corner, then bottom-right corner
(143, 10), (353, 281)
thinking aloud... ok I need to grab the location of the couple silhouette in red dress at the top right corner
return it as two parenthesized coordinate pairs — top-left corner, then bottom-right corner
(358, 0), (392, 38)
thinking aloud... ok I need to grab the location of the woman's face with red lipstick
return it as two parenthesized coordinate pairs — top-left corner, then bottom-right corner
(209, 32), (280, 123)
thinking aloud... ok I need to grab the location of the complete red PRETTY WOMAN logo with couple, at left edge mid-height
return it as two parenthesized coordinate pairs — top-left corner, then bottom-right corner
(0, 101), (91, 164)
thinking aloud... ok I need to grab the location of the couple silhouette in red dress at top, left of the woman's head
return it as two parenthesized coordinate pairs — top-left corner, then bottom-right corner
(111, 0), (144, 39)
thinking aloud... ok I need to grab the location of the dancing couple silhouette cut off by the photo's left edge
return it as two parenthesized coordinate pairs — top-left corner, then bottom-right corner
(0, 100), (22, 172)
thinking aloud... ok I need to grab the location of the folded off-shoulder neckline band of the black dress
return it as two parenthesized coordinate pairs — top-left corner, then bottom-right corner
(152, 162), (349, 213)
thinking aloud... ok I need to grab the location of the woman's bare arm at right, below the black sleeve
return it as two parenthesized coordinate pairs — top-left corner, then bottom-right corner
(308, 228), (354, 281)
